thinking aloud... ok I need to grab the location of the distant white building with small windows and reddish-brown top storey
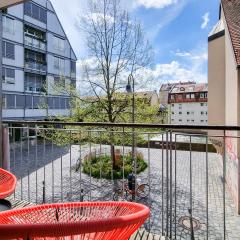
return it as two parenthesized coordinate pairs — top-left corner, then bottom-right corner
(168, 83), (208, 125)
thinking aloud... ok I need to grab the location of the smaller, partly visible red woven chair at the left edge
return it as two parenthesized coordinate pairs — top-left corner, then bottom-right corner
(0, 168), (17, 199)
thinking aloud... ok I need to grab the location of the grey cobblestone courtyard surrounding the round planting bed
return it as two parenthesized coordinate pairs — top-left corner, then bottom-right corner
(11, 143), (240, 240)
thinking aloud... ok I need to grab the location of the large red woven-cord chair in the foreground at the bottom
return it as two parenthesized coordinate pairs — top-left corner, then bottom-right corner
(0, 202), (150, 240)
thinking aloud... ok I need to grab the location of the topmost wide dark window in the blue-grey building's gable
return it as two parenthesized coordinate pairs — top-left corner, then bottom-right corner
(24, 2), (47, 23)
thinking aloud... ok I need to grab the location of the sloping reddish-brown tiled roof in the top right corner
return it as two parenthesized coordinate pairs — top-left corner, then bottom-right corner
(221, 0), (240, 66)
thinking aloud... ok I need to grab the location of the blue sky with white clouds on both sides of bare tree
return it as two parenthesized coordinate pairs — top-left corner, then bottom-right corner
(51, 0), (219, 91)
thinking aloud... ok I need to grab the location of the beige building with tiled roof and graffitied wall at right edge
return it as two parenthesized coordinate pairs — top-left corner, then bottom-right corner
(208, 0), (240, 213)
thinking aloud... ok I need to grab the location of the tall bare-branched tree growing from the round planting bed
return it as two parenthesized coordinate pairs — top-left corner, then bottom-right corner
(77, 0), (152, 168)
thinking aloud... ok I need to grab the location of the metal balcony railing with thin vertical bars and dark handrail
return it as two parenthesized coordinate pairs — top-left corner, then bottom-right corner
(1, 122), (240, 239)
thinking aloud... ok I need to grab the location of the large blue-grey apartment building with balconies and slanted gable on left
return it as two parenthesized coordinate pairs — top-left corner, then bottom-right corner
(2, 0), (77, 119)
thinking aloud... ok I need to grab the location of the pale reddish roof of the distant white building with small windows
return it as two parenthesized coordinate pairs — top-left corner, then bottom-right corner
(170, 83), (208, 93)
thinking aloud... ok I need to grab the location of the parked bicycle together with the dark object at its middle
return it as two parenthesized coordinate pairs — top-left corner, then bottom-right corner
(113, 174), (150, 201)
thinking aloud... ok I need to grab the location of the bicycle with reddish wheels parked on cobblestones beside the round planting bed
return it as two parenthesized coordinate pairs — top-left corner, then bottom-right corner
(113, 179), (150, 201)
